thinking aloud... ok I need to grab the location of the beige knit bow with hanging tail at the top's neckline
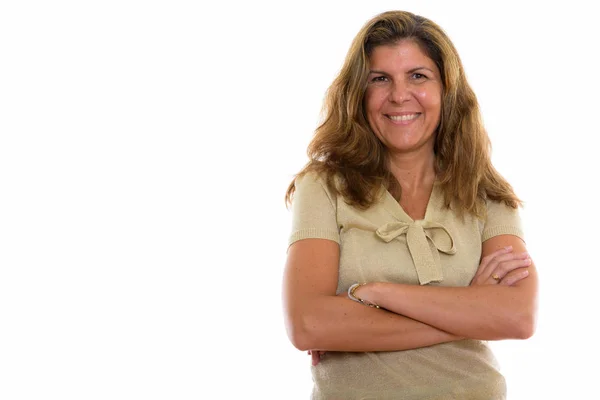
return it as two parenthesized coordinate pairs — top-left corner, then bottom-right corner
(375, 220), (456, 285)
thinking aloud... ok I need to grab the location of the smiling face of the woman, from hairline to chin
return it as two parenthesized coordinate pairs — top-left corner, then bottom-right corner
(365, 40), (442, 153)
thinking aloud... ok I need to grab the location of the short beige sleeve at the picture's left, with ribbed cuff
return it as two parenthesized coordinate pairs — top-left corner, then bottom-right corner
(288, 173), (340, 245)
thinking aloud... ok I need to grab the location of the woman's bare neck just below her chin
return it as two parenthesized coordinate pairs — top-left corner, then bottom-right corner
(389, 151), (435, 192)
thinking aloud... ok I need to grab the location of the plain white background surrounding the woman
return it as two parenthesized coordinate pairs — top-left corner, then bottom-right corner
(0, 1), (600, 400)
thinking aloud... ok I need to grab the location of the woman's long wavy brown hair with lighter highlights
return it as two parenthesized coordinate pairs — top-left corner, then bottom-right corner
(285, 11), (521, 216)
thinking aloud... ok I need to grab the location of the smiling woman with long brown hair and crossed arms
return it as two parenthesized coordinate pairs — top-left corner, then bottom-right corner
(283, 11), (537, 400)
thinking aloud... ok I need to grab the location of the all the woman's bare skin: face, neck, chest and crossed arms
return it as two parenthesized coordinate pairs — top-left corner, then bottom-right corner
(283, 40), (537, 364)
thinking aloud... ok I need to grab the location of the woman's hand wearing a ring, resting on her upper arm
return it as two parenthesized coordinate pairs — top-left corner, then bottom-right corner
(470, 246), (531, 286)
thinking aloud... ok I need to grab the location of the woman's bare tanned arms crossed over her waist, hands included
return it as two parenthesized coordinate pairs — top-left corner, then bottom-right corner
(283, 235), (537, 352)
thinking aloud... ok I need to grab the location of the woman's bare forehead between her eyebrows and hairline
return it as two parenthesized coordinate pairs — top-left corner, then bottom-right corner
(369, 39), (437, 72)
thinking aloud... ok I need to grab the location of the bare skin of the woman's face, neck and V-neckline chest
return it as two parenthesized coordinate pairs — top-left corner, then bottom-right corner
(365, 40), (443, 219)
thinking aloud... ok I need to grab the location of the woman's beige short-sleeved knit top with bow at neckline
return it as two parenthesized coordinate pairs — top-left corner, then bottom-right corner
(289, 174), (523, 400)
